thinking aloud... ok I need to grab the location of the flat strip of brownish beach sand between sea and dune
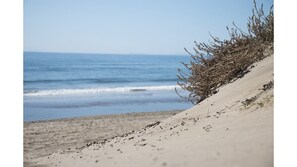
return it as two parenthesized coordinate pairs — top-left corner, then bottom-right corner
(24, 110), (182, 166)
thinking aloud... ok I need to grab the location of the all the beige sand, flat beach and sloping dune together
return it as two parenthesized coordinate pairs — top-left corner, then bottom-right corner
(24, 56), (274, 167)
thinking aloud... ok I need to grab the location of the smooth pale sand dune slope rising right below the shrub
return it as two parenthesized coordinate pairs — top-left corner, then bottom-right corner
(26, 56), (274, 167)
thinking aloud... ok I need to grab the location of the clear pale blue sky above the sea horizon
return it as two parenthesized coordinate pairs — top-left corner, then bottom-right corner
(24, 0), (273, 54)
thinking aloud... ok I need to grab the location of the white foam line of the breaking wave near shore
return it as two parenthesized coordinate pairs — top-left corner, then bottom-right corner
(24, 85), (179, 96)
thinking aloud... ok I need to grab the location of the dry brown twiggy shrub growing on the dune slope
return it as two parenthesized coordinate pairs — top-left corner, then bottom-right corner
(176, 1), (274, 104)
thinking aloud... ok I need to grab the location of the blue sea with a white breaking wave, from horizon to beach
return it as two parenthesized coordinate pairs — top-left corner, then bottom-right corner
(24, 52), (192, 122)
